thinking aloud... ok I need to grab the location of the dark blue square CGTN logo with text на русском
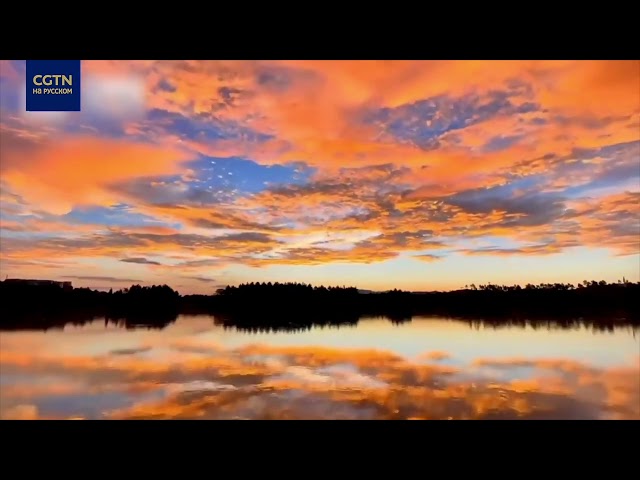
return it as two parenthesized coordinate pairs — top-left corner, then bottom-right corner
(26, 60), (81, 112)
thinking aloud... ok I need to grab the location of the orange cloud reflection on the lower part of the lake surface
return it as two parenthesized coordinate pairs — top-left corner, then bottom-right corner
(0, 338), (640, 419)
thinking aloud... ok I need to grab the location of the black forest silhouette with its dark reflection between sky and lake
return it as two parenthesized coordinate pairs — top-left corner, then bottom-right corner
(0, 279), (640, 331)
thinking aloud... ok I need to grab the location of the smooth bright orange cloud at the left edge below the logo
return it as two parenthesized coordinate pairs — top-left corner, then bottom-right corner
(0, 130), (189, 214)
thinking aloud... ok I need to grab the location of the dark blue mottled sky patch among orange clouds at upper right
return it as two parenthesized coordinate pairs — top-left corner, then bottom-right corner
(363, 87), (540, 149)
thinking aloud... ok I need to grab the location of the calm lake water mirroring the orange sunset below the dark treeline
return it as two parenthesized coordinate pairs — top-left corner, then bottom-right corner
(0, 315), (640, 419)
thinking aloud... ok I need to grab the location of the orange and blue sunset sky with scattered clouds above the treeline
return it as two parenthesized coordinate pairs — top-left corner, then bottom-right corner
(0, 60), (640, 294)
